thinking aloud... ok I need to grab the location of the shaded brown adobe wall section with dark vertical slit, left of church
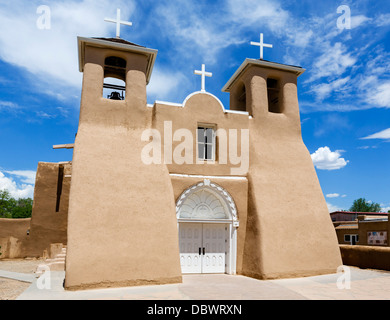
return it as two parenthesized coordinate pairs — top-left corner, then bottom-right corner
(23, 162), (72, 257)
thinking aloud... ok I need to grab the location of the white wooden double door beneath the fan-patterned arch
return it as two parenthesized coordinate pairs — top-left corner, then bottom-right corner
(179, 223), (228, 273)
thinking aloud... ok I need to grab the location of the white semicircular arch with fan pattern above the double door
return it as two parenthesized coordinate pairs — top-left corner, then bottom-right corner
(176, 179), (238, 221)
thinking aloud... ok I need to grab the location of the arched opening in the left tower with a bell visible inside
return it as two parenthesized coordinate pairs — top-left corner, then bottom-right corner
(103, 56), (126, 100)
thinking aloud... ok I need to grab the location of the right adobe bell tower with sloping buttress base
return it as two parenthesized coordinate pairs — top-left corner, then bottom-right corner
(223, 59), (342, 279)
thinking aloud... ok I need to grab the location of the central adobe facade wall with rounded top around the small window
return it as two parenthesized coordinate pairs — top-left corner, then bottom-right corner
(153, 92), (249, 176)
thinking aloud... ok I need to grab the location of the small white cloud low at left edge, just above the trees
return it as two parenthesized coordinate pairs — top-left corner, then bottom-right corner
(0, 171), (35, 199)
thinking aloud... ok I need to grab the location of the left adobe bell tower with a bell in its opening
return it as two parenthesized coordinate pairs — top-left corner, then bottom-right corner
(65, 37), (181, 290)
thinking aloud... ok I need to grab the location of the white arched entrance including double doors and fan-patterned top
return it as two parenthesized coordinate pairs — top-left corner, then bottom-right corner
(176, 179), (239, 274)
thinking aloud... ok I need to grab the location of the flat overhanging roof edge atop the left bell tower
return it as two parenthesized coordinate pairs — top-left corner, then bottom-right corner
(77, 37), (158, 83)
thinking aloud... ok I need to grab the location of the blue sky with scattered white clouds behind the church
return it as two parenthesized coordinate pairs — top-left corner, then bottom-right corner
(0, 0), (390, 211)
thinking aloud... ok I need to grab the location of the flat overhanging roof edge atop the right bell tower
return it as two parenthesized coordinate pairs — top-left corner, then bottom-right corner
(222, 58), (306, 92)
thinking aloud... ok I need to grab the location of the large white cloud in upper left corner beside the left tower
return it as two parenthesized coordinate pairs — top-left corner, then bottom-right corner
(0, 0), (132, 87)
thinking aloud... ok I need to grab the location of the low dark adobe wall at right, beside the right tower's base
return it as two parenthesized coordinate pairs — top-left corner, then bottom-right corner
(340, 245), (390, 271)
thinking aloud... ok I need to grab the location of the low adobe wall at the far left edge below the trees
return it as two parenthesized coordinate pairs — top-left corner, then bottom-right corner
(0, 218), (31, 259)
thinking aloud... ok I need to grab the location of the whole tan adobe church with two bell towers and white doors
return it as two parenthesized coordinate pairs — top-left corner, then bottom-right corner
(0, 12), (342, 290)
